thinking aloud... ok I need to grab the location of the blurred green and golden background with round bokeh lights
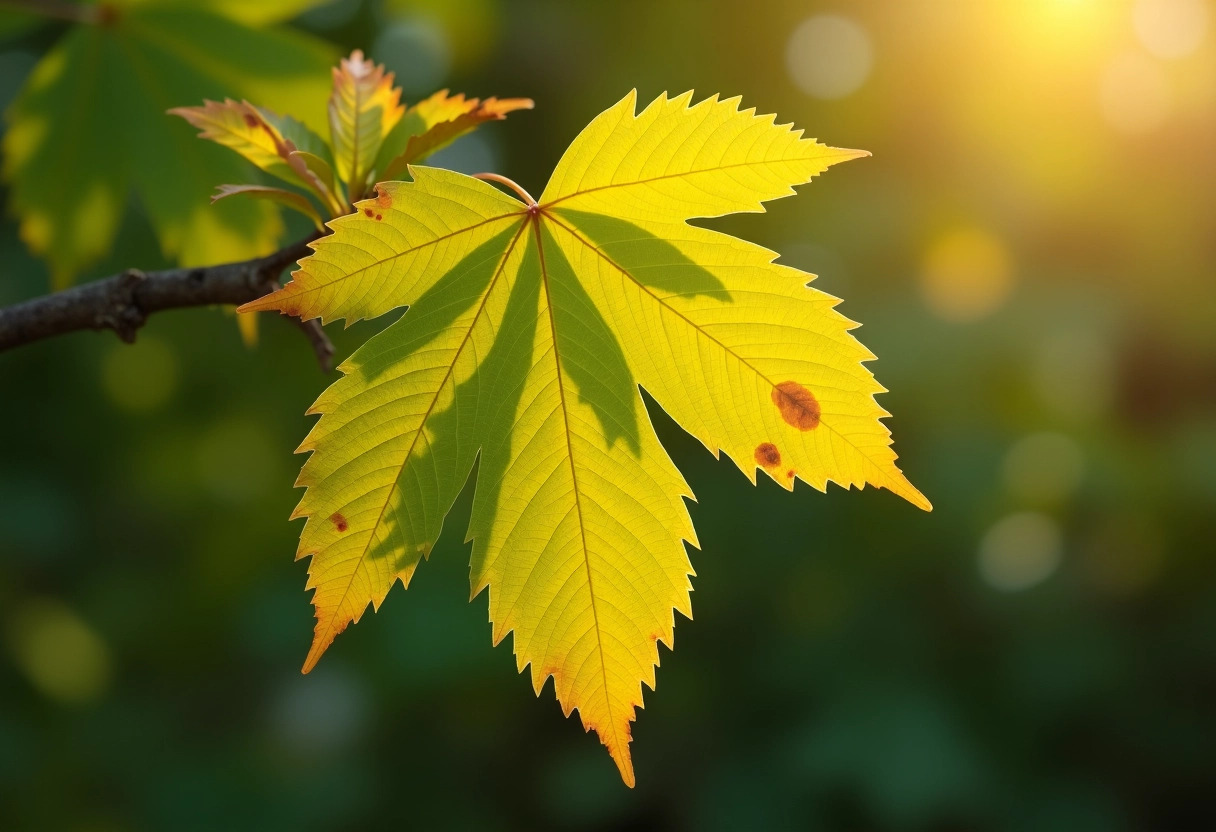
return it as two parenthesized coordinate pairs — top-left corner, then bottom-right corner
(0, 0), (1216, 832)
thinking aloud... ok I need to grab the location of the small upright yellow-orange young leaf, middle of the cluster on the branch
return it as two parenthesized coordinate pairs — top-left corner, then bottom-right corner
(330, 49), (405, 199)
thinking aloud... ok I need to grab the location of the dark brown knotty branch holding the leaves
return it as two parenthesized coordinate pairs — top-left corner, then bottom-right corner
(0, 237), (333, 372)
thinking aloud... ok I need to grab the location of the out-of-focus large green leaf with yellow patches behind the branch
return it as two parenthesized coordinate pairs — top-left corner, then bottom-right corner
(4, 4), (332, 286)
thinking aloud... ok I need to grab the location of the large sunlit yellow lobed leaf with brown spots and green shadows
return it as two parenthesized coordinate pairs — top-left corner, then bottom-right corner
(244, 94), (929, 785)
